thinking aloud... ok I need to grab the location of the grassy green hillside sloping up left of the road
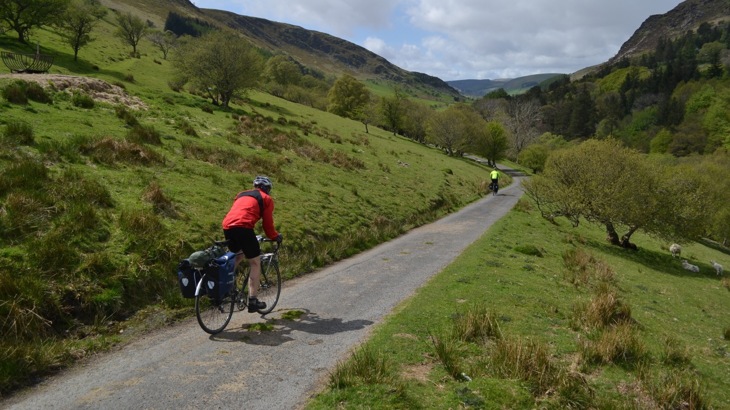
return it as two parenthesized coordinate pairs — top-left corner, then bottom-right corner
(0, 13), (489, 394)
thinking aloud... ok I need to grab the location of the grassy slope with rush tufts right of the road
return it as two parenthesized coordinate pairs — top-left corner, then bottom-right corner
(307, 199), (730, 409)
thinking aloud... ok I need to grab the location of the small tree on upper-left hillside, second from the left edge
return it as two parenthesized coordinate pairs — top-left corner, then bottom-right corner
(58, 0), (106, 61)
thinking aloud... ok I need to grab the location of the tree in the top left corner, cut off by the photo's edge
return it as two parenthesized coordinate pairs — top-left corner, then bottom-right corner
(0, 0), (69, 43)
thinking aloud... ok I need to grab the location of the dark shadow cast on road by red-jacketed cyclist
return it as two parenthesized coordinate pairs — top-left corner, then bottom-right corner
(210, 309), (373, 346)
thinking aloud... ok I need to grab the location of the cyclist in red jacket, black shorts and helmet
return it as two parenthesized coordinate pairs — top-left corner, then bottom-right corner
(222, 176), (282, 312)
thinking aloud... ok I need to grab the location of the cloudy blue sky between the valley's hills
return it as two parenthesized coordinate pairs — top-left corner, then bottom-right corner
(191, 0), (681, 81)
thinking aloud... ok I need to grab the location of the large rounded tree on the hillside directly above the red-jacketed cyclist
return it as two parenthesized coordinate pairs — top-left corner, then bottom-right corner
(175, 31), (264, 107)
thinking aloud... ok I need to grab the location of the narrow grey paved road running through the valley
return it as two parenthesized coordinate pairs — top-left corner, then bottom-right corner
(0, 171), (522, 410)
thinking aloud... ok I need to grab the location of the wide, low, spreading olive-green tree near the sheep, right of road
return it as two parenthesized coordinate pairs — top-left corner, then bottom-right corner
(525, 140), (711, 248)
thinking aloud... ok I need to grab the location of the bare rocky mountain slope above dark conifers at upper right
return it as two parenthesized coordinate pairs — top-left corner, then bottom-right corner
(609, 0), (730, 62)
